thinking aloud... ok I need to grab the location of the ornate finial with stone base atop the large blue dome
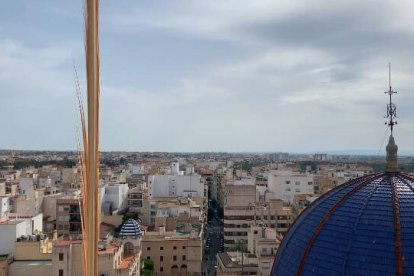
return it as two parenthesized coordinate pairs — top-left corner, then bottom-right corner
(385, 63), (399, 172)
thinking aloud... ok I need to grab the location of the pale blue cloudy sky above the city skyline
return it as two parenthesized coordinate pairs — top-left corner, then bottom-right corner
(0, 0), (414, 152)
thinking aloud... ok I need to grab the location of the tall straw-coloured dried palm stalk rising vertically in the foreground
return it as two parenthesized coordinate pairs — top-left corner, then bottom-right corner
(85, 0), (99, 276)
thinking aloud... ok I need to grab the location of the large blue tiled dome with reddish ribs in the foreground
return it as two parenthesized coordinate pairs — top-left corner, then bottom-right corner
(272, 172), (414, 276)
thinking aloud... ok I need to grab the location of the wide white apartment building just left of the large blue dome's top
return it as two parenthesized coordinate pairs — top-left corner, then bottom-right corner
(266, 170), (315, 203)
